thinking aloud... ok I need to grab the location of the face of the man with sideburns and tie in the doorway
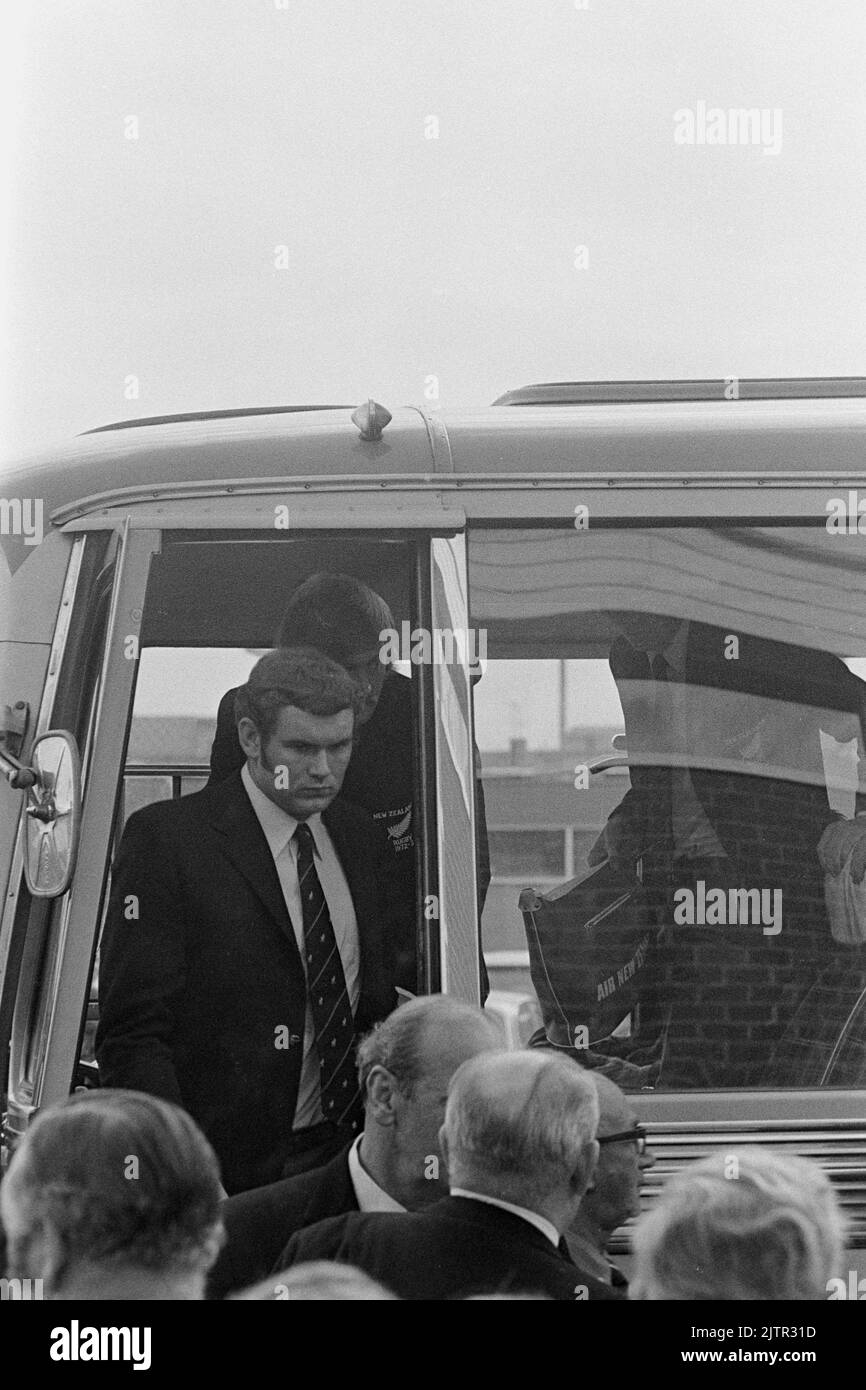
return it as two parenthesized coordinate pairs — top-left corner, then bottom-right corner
(238, 705), (354, 820)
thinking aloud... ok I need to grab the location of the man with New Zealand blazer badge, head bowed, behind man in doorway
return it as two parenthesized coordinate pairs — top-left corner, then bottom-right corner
(202, 573), (491, 995)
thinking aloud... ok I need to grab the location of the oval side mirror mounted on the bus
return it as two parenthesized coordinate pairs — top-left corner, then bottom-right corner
(24, 728), (81, 898)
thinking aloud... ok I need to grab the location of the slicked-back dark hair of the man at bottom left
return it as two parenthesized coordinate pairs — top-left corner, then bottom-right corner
(10, 1090), (224, 1286)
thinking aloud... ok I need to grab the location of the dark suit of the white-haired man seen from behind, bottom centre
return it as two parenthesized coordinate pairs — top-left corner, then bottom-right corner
(272, 1197), (623, 1302)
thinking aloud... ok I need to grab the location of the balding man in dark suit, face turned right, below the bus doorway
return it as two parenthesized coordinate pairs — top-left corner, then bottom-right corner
(209, 994), (502, 1298)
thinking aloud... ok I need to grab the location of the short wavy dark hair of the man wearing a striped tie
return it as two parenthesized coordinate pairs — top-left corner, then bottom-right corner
(235, 646), (363, 739)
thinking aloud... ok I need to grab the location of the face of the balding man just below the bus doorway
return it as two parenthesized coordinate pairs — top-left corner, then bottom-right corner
(395, 1022), (502, 1205)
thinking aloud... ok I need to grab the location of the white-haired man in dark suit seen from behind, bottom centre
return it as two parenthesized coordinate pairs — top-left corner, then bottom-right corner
(272, 1052), (623, 1302)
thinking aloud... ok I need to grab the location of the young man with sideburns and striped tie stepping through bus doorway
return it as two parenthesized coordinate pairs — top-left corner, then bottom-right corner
(96, 649), (405, 1193)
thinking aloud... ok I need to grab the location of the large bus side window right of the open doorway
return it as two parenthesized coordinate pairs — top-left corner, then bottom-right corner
(468, 527), (866, 1090)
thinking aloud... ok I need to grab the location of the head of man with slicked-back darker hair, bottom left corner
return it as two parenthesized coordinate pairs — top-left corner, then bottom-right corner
(0, 1090), (224, 1301)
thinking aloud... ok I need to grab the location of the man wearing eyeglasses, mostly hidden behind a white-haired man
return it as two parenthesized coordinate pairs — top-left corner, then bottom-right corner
(566, 1072), (656, 1293)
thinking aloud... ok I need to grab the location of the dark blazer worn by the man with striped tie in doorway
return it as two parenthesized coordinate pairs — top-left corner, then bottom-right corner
(96, 773), (395, 1193)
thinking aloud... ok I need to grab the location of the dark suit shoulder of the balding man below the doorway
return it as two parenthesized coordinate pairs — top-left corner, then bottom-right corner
(207, 1147), (357, 1298)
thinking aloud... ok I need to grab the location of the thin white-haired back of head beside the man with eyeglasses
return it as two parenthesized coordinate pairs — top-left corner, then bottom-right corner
(442, 1051), (599, 1209)
